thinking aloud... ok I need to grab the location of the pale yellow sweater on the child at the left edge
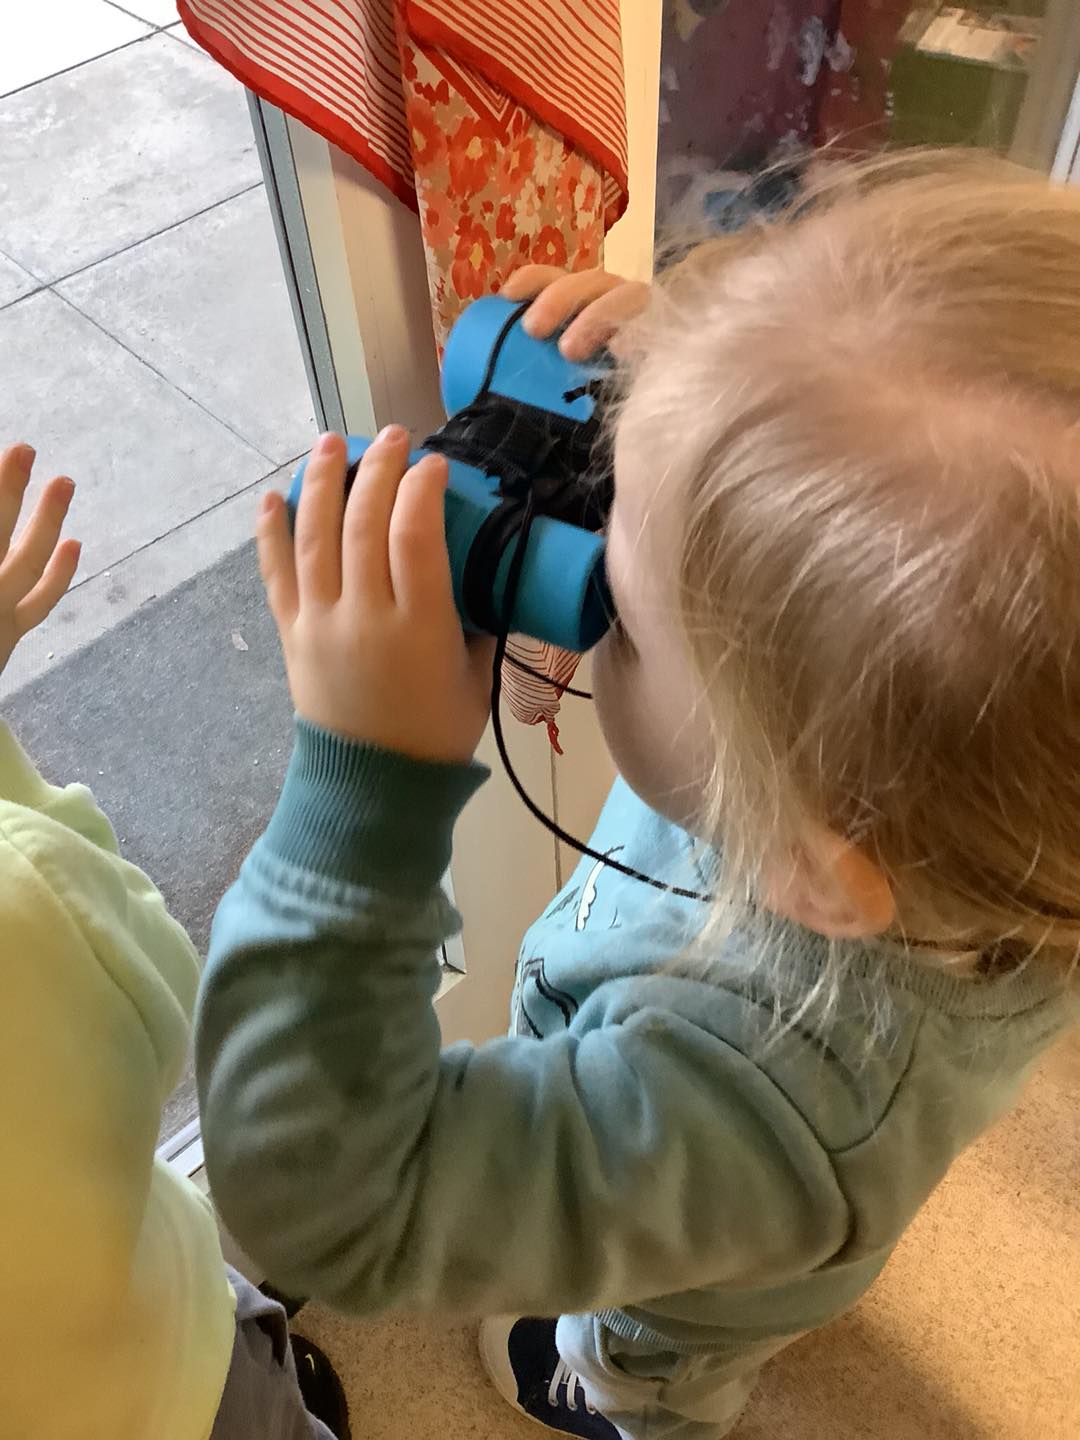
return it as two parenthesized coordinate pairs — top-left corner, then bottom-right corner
(0, 724), (235, 1440)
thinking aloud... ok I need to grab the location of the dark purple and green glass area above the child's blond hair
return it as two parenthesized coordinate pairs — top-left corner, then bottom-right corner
(658, 0), (1080, 222)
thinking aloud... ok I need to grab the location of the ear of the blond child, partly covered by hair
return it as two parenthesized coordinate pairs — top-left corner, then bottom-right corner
(765, 825), (896, 940)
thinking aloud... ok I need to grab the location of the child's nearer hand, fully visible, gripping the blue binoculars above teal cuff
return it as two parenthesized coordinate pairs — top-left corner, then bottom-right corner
(258, 426), (494, 760)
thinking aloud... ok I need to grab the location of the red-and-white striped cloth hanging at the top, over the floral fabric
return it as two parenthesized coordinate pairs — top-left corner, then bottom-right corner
(179, 0), (626, 225)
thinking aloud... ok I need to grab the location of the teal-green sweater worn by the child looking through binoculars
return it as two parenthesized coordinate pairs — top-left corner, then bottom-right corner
(197, 724), (1076, 1358)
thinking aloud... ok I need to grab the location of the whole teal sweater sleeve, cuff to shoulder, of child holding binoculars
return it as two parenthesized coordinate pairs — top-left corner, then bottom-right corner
(196, 726), (848, 1315)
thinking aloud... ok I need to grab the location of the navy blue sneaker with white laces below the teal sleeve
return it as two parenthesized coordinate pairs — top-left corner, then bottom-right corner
(480, 1318), (622, 1440)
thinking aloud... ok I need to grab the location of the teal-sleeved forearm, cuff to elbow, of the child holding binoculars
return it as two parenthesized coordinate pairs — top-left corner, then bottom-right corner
(196, 721), (487, 1306)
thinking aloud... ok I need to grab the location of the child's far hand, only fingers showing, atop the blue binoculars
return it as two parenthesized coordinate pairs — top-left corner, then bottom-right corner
(501, 265), (649, 360)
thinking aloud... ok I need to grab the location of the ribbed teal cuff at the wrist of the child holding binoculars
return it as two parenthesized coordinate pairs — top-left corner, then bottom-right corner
(264, 720), (490, 896)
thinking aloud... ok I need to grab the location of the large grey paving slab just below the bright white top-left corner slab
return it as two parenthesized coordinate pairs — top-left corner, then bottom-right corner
(0, 33), (262, 281)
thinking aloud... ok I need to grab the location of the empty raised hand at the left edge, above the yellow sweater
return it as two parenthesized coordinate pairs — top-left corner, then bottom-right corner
(0, 445), (81, 670)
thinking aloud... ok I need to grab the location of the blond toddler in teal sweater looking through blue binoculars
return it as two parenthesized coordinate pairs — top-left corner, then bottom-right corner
(197, 154), (1080, 1440)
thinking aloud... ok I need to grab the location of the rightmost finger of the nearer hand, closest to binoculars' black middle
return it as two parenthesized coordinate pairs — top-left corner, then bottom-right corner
(390, 455), (454, 619)
